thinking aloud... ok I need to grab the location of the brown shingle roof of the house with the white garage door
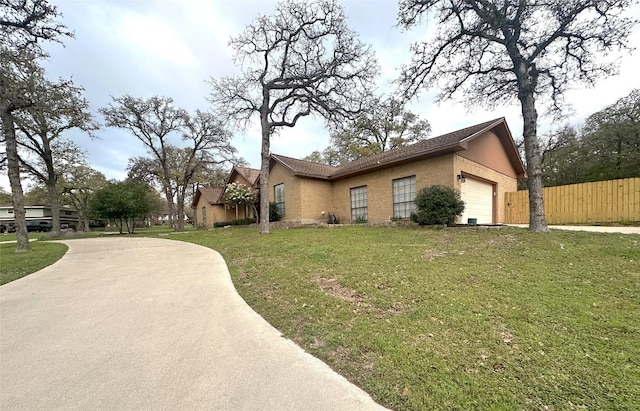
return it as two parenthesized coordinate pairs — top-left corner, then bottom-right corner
(271, 118), (524, 179)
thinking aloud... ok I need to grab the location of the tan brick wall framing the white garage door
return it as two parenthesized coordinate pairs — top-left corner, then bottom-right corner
(453, 155), (518, 224)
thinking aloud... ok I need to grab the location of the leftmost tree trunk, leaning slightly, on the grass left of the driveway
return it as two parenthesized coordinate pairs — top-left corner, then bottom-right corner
(0, 101), (31, 252)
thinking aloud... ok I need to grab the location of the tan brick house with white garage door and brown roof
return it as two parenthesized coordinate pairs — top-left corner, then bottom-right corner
(269, 118), (525, 224)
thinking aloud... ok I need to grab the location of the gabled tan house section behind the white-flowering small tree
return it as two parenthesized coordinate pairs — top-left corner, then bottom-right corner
(191, 166), (260, 227)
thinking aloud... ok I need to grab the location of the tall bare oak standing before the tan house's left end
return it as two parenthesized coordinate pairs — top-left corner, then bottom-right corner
(210, 0), (378, 233)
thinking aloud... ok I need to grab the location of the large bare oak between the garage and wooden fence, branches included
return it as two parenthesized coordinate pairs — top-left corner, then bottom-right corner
(399, 0), (636, 231)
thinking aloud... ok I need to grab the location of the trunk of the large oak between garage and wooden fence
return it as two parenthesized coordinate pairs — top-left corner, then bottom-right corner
(520, 92), (549, 232)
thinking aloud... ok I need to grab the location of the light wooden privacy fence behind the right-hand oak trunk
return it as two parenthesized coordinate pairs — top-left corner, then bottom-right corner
(504, 177), (640, 224)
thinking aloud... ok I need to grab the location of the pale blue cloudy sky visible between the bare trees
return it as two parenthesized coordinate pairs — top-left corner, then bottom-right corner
(0, 0), (640, 188)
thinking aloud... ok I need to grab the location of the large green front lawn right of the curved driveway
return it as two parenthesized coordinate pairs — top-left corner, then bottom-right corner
(179, 227), (640, 410)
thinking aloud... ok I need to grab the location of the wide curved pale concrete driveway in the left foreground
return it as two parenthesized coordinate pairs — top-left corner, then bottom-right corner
(0, 237), (383, 410)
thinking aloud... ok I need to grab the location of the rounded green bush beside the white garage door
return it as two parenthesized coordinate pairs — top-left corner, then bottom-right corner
(411, 185), (464, 225)
